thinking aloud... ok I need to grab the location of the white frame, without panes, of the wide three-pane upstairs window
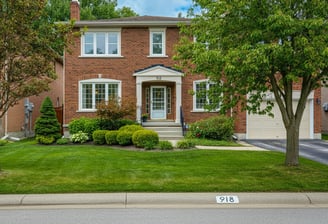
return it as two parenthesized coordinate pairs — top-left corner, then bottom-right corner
(81, 29), (122, 57)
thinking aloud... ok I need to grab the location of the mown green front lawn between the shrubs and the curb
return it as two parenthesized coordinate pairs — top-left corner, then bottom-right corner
(0, 141), (328, 193)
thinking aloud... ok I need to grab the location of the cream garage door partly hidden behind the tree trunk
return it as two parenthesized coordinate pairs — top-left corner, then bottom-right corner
(247, 101), (311, 139)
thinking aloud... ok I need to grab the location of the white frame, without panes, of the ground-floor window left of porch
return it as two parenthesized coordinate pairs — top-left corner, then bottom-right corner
(79, 78), (122, 112)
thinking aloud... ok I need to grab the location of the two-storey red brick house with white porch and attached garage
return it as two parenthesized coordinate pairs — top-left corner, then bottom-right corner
(64, 0), (321, 139)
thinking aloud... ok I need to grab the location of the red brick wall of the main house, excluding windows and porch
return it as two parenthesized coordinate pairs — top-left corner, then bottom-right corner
(64, 24), (321, 137)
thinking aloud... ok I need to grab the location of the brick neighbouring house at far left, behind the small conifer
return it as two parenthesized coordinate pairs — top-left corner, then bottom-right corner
(0, 59), (64, 138)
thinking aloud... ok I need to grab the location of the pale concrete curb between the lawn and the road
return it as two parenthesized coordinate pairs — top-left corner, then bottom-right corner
(0, 193), (328, 208)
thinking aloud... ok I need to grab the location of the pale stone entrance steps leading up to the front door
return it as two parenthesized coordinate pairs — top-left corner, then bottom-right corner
(142, 120), (183, 140)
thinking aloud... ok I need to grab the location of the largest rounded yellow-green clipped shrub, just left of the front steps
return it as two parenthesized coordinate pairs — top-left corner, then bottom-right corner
(132, 129), (159, 148)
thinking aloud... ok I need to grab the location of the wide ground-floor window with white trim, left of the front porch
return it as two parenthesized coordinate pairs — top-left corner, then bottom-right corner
(79, 79), (122, 111)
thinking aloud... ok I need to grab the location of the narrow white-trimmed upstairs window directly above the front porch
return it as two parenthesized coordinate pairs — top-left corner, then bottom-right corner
(149, 29), (166, 57)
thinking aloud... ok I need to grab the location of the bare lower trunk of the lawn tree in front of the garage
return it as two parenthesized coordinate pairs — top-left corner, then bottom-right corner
(285, 123), (299, 166)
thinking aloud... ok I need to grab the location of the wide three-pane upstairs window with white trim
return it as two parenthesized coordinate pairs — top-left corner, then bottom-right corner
(81, 29), (121, 57)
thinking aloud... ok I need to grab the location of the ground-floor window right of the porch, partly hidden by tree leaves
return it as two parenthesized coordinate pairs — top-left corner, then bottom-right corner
(193, 79), (220, 112)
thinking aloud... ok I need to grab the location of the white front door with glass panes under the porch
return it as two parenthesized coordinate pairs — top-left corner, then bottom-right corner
(150, 86), (166, 119)
